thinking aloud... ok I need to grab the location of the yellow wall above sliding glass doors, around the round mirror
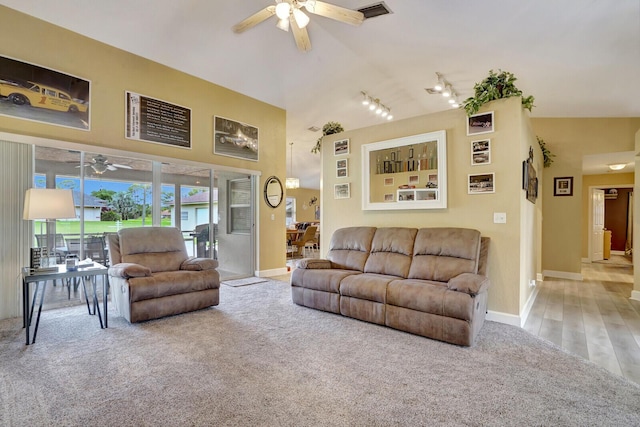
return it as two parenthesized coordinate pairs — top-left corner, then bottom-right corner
(0, 6), (286, 278)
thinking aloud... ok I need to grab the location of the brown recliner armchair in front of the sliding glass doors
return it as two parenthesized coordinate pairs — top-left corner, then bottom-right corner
(108, 227), (220, 323)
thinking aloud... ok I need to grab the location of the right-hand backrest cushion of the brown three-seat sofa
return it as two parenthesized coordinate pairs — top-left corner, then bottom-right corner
(408, 228), (481, 282)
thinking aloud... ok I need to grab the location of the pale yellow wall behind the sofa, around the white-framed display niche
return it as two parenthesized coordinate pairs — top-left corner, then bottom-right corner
(321, 98), (541, 318)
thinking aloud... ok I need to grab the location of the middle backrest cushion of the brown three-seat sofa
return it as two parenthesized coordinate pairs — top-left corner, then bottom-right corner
(364, 227), (418, 278)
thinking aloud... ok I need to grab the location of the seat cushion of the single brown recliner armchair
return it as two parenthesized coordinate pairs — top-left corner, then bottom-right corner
(129, 270), (220, 303)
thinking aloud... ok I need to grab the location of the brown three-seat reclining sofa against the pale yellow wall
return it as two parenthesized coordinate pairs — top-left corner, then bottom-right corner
(291, 227), (490, 346)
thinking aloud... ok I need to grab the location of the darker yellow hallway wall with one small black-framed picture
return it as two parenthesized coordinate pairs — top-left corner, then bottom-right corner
(531, 118), (640, 275)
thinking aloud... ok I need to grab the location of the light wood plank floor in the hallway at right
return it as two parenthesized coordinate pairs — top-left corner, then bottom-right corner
(524, 260), (640, 384)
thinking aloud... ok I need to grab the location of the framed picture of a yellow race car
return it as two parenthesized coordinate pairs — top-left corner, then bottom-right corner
(0, 56), (91, 131)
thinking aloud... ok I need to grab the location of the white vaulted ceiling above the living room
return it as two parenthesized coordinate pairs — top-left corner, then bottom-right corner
(0, 0), (640, 188)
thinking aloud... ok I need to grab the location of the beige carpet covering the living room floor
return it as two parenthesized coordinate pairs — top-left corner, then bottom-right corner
(0, 281), (640, 427)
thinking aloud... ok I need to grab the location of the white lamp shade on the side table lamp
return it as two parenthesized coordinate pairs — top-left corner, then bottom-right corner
(22, 188), (76, 220)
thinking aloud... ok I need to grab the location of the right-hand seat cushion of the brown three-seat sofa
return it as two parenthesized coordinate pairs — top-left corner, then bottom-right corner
(387, 279), (475, 320)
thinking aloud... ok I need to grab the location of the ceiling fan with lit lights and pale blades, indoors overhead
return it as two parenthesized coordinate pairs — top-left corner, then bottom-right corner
(233, 0), (364, 52)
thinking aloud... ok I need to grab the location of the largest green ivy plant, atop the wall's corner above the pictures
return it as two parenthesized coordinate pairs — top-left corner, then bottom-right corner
(462, 70), (534, 116)
